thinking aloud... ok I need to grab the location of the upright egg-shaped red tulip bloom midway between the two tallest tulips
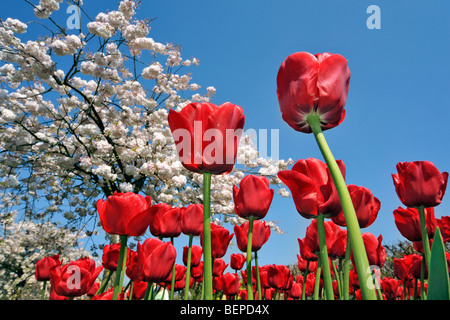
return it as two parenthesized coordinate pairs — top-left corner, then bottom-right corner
(233, 175), (274, 219)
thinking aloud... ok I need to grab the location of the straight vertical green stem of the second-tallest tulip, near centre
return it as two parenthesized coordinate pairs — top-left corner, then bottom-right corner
(203, 172), (213, 300)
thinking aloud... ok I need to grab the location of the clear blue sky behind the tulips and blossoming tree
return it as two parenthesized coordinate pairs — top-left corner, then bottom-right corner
(1, 0), (450, 272)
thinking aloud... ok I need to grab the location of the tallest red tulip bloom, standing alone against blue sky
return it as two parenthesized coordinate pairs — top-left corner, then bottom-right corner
(277, 52), (350, 133)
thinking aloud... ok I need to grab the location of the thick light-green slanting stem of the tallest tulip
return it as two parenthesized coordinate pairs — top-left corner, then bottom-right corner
(307, 114), (377, 300)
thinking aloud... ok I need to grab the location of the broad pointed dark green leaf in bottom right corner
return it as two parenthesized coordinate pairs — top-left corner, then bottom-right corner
(427, 228), (450, 300)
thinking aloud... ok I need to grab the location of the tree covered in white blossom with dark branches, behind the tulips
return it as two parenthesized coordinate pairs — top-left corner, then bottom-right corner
(0, 0), (292, 298)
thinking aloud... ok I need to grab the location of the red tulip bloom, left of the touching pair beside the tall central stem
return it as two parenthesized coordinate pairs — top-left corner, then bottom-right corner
(150, 203), (181, 238)
